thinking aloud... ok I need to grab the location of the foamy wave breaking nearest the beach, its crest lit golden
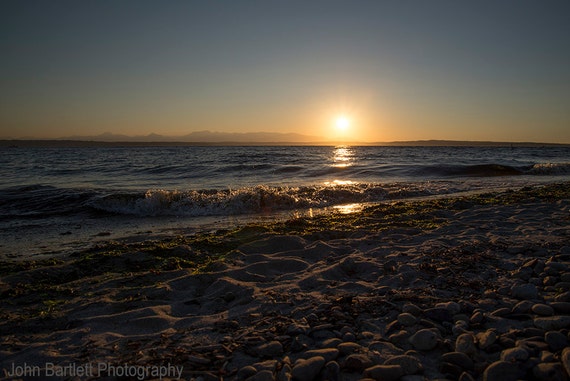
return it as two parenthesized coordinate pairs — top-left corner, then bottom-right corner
(90, 183), (432, 216)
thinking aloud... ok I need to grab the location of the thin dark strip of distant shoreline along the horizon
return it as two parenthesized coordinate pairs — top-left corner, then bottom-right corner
(0, 139), (570, 148)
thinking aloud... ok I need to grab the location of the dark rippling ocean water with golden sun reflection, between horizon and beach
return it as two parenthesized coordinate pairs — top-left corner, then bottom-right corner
(0, 146), (570, 258)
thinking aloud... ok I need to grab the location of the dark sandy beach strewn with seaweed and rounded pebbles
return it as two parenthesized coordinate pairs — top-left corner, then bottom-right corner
(0, 183), (570, 381)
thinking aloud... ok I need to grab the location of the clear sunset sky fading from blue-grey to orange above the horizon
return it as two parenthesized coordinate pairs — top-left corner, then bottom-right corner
(0, 0), (570, 143)
